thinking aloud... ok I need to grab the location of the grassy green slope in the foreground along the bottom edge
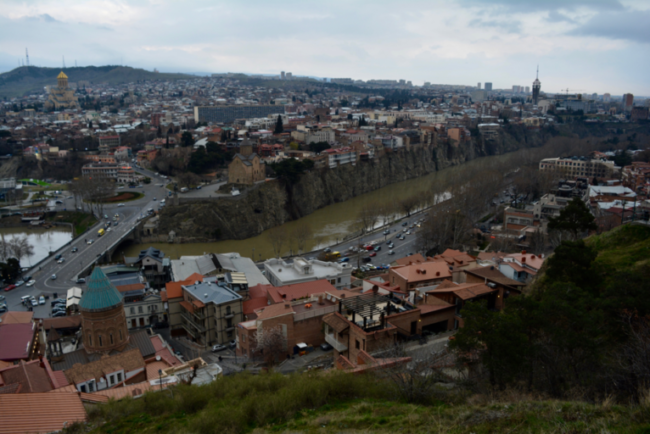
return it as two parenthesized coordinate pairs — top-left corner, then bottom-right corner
(64, 371), (650, 434)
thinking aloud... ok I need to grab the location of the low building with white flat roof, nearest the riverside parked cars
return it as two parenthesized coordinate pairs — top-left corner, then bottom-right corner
(264, 257), (352, 289)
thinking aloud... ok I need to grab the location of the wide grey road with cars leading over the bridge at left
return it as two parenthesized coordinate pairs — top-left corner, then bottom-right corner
(2, 169), (168, 318)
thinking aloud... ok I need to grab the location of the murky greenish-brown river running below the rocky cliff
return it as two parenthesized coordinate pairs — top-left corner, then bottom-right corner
(118, 150), (526, 261)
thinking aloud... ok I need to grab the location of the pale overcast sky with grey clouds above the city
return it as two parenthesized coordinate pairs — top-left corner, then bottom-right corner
(0, 0), (650, 96)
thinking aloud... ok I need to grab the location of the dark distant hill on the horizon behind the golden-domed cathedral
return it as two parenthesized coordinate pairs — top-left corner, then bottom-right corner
(0, 65), (196, 97)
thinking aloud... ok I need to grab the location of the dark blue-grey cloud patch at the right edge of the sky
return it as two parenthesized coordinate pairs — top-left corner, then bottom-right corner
(567, 11), (650, 43)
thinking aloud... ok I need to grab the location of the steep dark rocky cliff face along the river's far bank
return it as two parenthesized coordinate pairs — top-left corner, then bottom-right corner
(158, 127), (551, 241)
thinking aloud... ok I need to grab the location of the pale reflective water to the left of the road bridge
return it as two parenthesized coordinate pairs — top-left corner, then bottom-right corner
(0, 225), (72, 267)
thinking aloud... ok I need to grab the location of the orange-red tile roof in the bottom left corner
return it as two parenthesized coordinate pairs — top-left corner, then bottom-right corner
(0, 392), (86, 434)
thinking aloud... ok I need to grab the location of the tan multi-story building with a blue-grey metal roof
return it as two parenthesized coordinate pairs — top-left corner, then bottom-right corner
(180, 277), (244, 348)
